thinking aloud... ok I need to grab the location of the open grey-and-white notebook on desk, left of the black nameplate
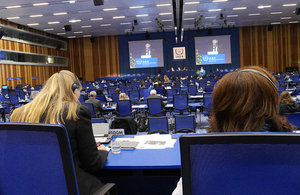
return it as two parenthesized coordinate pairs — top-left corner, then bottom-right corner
(92, 123), (113, 144)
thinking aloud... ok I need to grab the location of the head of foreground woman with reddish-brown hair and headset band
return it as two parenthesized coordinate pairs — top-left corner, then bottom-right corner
(209, 67), (292, 132)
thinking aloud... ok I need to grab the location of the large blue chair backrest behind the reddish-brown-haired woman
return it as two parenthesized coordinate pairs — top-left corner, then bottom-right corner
(179, 133), (300, 195)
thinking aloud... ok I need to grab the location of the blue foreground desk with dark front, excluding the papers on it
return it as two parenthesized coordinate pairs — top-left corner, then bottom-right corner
(100, 135), (181, 195)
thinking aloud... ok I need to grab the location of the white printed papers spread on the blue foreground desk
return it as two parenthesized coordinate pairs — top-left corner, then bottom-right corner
(134, 134), (176, 149)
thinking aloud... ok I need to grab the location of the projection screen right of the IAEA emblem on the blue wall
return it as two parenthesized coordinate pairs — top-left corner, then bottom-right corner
(195, 35), (231, 65)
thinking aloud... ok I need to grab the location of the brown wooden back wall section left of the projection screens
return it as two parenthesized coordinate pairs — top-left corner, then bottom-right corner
(68, 35), (120, 81)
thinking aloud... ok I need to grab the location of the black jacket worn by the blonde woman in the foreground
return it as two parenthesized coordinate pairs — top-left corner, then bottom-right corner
(40, 106), (108, 195)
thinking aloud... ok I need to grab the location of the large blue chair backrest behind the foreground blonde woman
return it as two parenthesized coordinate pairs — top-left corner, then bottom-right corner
(0, 123), (79, 195)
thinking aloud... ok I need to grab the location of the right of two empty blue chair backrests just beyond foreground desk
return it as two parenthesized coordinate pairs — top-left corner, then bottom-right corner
(175, 115), (195, 133)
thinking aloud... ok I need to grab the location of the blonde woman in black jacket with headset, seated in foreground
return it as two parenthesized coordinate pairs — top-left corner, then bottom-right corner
(11, 70), (108, 194)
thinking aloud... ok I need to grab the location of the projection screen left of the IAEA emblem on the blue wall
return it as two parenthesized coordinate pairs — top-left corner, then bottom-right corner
(128, 39), (164, 69)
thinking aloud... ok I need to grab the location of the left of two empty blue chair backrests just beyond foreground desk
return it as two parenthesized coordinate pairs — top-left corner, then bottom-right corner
(148, 117), (169, 134)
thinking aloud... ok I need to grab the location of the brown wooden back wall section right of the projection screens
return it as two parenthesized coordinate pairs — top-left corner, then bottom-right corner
(240, 24), (300, 72)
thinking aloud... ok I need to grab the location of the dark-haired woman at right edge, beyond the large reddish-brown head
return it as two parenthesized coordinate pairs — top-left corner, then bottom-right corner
(279, 91), (300, 115)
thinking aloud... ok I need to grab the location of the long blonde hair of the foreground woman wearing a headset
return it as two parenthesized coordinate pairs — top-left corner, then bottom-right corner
(10, 70), (81, 124)
